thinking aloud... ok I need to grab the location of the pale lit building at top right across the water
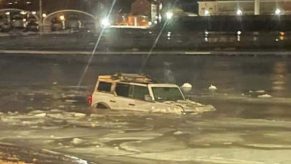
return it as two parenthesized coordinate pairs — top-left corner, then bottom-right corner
(198, 0), (291, 16)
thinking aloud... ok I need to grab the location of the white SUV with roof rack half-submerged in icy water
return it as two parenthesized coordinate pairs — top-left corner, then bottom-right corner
(88, 74), (215, 114)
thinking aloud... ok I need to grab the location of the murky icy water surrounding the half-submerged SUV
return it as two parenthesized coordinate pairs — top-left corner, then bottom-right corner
(0, 55), (291, 164)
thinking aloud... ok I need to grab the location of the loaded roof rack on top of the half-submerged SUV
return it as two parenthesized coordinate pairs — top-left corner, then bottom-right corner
(112, 73), (153, 83)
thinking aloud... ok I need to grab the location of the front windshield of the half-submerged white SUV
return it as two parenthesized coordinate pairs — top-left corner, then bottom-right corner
(152, 87), (184, 101)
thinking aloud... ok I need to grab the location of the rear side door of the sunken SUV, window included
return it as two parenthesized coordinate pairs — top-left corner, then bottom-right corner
(110, 83), (135, 110)
